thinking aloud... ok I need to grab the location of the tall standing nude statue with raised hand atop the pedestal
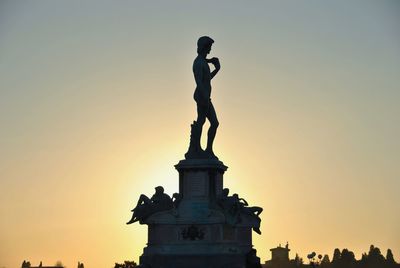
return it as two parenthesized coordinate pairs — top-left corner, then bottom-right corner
(185, 36), (221, 159)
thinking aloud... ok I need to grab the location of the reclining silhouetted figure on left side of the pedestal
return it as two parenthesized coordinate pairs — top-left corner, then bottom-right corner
(126, 186), (173, 224)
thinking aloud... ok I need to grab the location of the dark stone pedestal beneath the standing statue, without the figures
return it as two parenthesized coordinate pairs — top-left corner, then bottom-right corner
(134, 159), (260, 268)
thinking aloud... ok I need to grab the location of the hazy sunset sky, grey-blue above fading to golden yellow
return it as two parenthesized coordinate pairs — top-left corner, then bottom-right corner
(0, 0), (400, 268)
